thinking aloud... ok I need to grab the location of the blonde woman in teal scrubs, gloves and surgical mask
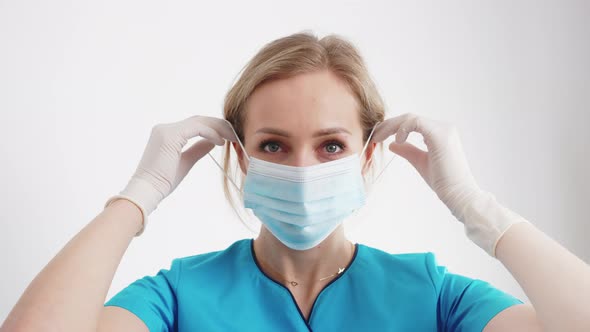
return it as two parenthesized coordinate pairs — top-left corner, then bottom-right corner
(2, 34), (590, 332)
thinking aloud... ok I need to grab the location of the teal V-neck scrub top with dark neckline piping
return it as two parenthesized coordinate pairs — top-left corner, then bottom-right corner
(104, 239), (523, 332)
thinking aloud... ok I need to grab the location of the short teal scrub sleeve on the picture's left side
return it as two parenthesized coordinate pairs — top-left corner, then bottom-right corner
(104, 259), (181, 332)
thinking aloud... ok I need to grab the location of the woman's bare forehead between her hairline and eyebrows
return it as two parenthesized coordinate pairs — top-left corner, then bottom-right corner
(244, 70), (362, 134)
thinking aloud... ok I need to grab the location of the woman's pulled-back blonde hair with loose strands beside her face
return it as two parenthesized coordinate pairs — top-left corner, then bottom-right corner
(223, 32), (385, 231)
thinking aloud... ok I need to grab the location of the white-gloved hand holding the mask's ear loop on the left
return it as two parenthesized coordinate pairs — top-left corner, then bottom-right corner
(105, 115), (236, 236)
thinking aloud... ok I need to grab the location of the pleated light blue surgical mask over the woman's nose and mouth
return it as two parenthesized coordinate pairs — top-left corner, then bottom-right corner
(213, 123), (384, 250)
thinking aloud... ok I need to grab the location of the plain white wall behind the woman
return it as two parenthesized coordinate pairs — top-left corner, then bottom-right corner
(0, 0), (590, 321)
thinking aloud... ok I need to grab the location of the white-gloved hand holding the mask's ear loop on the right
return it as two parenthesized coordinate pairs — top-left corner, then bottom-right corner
(372, 113), (528, 257)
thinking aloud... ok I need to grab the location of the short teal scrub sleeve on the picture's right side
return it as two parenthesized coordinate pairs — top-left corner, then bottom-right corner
(426, 253), (523, 331)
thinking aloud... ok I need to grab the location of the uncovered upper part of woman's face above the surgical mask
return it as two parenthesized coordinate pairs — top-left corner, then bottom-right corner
(234, 70), (375, 173)
